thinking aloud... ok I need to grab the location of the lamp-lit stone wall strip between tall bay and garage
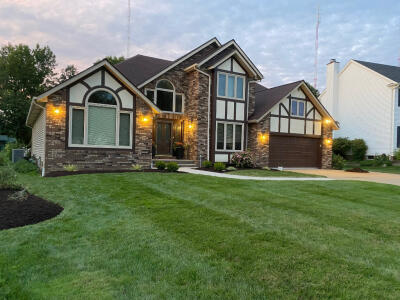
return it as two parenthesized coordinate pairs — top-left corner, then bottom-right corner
(248, 117), (270, 167)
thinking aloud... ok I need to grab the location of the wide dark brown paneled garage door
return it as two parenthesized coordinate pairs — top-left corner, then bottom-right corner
(269, 135), (321, 168)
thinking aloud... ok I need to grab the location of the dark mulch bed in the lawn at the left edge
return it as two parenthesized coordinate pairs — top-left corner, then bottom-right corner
(0, 190), (63, 230)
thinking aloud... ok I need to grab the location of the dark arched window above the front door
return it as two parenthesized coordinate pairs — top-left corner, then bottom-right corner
(145, 79), (183, 113)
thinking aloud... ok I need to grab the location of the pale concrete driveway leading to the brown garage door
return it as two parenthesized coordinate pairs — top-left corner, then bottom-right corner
(287, 169), (400, 186)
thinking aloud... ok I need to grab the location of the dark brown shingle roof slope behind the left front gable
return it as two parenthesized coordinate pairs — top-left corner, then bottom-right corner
(115, 54), (174, 86)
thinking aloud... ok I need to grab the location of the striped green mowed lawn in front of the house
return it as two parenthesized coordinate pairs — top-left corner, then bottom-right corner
(0, 173), (400, 299)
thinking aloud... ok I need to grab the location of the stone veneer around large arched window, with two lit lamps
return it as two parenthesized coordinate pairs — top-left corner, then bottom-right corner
(45, 90), (153, 174)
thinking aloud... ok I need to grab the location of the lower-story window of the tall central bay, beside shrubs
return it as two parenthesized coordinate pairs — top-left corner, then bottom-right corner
(216, 122), (243, 151)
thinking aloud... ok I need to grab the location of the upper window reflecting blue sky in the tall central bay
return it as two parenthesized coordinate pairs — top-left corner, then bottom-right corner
(218, 72), (244, 100)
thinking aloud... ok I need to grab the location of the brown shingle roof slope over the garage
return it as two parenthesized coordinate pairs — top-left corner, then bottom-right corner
(249, 80), (302, 120)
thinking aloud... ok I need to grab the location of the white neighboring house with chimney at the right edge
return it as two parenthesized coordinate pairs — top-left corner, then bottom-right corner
(320, 59), (400, 157)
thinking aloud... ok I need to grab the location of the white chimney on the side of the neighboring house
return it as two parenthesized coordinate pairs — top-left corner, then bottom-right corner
(323, 58), (339, 120)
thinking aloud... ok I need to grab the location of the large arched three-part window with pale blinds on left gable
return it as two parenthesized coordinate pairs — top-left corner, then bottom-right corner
(70, 90), (132, 148)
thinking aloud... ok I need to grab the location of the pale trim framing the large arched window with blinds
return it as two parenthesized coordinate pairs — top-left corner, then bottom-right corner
(68, 88), (133, 149)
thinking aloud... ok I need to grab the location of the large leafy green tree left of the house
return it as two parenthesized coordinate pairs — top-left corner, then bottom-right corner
(0, 44), (56, 143)
